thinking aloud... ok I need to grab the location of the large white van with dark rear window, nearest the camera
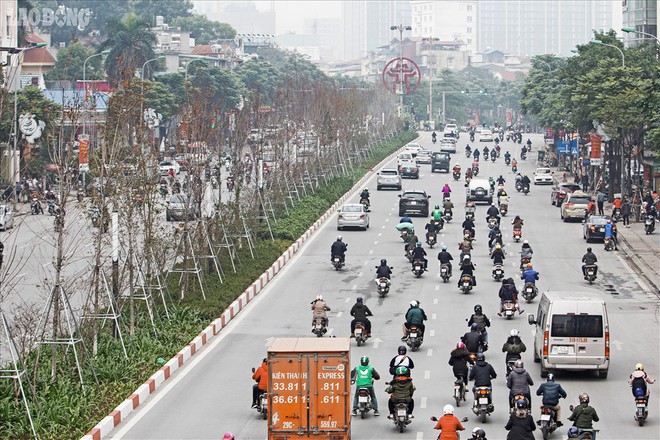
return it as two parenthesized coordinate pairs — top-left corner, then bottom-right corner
(527, 292), (610, 378)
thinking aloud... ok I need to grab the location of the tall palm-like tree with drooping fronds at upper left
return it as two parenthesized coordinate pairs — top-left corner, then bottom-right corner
(100, 13), (157, 85)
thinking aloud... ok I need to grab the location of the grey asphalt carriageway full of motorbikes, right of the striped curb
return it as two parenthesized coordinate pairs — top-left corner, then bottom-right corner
(105, 133), (660, 440)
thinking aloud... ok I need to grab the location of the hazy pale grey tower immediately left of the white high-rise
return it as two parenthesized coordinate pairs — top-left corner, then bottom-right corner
(342, 0), (411, 59)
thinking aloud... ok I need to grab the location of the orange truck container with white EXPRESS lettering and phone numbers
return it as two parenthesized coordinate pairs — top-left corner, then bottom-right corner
(268, 338), (351, 440)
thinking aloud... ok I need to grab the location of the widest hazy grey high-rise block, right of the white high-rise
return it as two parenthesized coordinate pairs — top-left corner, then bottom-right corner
(477, 0), (616, 56)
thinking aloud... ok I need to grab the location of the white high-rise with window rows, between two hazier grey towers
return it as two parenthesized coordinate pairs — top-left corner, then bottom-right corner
(410, 0), (477, 55)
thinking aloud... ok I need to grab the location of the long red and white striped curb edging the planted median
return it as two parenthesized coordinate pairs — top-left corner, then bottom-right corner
(81, 135), (412, 440)
